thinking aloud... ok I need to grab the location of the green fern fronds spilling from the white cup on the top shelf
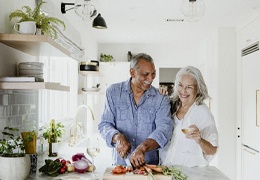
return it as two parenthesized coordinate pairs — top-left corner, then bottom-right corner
(9, 1), (66, 39)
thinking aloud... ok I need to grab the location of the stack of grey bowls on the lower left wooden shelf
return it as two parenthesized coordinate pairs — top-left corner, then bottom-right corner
(18, 62), (44, 79)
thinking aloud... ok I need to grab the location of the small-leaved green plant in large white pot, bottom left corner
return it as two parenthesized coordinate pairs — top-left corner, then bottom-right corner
(0, 127), (31, 180)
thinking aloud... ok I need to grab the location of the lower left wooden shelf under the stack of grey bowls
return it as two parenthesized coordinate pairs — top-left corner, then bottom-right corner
(0, 82), (70, 91)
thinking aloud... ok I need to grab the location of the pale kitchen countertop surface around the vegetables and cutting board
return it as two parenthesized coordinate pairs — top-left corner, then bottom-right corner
(27, 141), (229, 180)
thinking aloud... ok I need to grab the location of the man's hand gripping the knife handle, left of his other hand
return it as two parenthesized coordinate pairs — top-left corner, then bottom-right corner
(113, 134), (131, 159)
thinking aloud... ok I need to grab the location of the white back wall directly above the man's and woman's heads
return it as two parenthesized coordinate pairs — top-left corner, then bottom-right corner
(98, 42), (203, 87)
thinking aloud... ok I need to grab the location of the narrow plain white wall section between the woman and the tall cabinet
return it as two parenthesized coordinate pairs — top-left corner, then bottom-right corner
(217, 28), (236, 179)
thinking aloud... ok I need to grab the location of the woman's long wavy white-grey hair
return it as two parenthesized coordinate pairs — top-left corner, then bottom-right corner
(171, 66), (210, 112)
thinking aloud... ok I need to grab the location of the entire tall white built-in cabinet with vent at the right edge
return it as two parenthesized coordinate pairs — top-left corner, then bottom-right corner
(237, 15), (260, 180)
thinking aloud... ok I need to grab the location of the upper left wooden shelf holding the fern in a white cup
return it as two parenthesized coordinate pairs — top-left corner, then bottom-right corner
(0, 33), (71, 56)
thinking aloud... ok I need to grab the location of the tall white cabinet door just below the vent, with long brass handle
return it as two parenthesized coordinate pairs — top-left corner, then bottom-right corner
(241, 50), (260, 150)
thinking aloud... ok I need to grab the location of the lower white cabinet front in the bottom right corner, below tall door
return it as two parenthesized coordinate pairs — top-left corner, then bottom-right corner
(242, 147), (260, 180)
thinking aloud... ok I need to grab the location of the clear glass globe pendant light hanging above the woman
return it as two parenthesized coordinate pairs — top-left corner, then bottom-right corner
(180, 0), (205, 22)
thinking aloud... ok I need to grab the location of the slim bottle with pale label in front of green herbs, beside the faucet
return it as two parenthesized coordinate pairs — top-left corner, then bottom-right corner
(48, 119), (58, 157)
